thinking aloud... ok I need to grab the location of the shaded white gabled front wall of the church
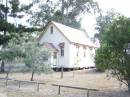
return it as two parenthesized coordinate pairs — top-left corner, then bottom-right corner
(40, 24), (70, 67)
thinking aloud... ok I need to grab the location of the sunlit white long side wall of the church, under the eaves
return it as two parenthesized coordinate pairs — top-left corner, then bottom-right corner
(70, 44), (95, 68)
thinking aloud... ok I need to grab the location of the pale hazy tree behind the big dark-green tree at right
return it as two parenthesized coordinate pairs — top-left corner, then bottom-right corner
(94, 9), (120, 43)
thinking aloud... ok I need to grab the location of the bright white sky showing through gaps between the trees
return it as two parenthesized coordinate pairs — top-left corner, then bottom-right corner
(0, 0), (130, 37)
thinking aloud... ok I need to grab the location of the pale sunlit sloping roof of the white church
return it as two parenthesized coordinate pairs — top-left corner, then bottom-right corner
(51, 21), (96, 47)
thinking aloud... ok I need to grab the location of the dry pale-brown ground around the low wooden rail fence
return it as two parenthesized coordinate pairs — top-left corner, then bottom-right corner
(0, 70), (130, 97)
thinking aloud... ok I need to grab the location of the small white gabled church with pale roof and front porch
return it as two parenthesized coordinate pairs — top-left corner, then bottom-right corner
(39, 21), (96, 68)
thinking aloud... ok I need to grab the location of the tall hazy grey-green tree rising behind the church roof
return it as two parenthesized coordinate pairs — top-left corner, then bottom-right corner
(29, 0), (97, 29)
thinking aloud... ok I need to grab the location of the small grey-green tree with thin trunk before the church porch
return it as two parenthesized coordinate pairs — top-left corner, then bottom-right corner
(23, 42), (51, 81)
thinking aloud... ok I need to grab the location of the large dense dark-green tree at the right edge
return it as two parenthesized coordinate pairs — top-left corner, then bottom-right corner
(96, 16), (130, 91)
